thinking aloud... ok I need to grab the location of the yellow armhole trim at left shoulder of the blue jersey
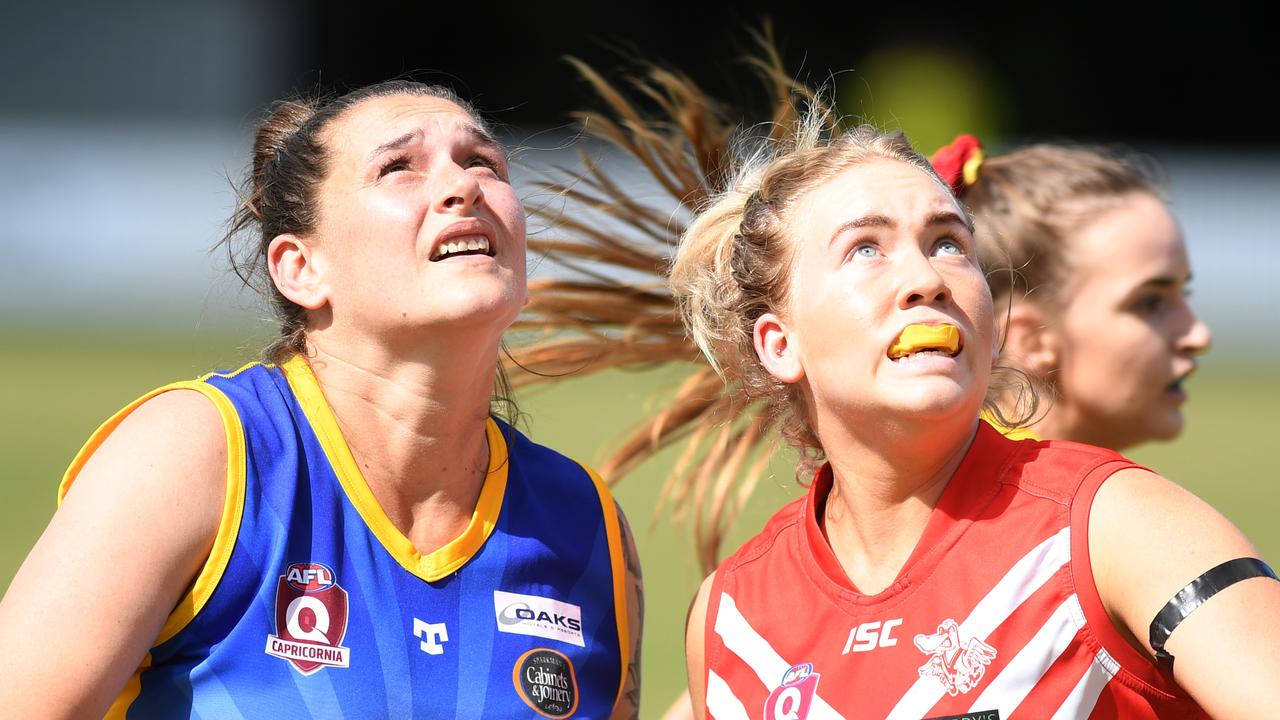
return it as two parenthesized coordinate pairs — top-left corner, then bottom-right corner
(58, 380), (244, 646)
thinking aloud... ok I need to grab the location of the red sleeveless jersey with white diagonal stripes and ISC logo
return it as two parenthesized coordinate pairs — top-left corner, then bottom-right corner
(705, 423), (1206, 720)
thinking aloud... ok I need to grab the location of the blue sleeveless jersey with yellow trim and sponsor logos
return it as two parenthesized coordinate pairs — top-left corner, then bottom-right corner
(59, 359), (628, 719)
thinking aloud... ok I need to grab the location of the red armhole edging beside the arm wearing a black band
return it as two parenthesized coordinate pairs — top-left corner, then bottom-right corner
(1071, 460), (1175, 698)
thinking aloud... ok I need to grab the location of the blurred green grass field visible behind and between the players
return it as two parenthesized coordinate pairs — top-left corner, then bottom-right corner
(0, 325), (1280, 716)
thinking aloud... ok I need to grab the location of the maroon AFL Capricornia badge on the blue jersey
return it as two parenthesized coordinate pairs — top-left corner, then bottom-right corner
(266, 562), (351, 675)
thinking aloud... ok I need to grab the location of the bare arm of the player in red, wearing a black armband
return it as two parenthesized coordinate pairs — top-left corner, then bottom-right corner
(1089, 469), (1280, 717)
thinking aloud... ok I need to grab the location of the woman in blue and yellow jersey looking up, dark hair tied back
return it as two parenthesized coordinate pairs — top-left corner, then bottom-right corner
(0, 82), (641, 717)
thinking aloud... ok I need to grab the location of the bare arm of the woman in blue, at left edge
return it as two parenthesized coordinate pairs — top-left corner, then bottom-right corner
(0, 391), (227, 717)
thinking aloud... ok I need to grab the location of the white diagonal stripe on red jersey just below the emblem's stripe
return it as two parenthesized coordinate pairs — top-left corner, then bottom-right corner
(969, 594), (1084, 714)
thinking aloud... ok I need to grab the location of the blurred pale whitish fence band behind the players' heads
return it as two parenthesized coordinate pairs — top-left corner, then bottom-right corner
(0, 122), (1280, 355)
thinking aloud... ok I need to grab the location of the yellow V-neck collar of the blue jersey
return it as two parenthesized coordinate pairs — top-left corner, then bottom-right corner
(282, 356), (508, 583)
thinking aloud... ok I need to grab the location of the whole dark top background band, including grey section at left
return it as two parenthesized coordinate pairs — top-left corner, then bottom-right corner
(0, 0), (1277, 147)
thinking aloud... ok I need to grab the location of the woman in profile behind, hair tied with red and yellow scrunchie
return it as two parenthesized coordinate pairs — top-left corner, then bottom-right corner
(933, 136), (1210, 450)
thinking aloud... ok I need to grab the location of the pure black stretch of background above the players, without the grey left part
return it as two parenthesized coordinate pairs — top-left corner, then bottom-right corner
(300, 3), (1276, 143)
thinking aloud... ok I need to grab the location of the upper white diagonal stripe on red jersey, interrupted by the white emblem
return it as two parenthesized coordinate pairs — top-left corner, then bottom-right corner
(887, 520), (1071, 720)
